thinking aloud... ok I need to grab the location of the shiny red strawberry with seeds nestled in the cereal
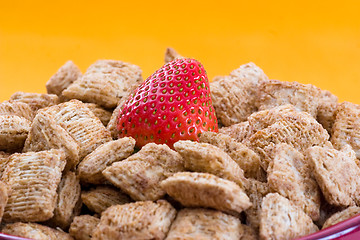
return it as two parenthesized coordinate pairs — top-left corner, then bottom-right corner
(117, 59), (218, 147)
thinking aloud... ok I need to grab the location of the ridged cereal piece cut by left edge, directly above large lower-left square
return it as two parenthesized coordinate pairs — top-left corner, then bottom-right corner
(0, 115), (31, 151)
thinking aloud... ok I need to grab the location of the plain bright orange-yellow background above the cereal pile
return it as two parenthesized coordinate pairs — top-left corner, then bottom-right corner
(0, 0), (360, 104)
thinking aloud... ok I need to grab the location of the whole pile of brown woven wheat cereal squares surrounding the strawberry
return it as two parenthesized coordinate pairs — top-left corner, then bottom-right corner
(0, 49), (360, 240)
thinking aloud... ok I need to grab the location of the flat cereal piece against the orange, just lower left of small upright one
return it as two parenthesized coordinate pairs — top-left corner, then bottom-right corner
(10, 92), (60, 112)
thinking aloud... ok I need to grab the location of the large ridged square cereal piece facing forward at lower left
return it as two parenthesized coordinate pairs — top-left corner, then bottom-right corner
(1, 149), (66, 222)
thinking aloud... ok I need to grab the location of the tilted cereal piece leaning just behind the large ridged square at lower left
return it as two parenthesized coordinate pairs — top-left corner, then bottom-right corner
(23, 109), (80, 170)
